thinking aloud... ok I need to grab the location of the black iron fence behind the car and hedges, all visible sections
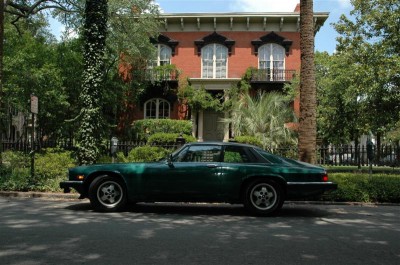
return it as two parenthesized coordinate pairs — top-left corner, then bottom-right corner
(2, 140), (400, 167)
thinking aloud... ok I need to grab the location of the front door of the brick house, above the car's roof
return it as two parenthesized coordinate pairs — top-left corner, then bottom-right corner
(203, 110), (225, 141)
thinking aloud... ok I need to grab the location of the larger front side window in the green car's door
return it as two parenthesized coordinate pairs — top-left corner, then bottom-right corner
(182, 145), (221, 163)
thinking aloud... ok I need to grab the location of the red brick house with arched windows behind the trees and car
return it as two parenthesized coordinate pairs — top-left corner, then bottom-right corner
(122, 6), (328, 141)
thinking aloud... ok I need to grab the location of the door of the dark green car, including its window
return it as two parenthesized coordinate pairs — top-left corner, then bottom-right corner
(144, 145), (221, 201)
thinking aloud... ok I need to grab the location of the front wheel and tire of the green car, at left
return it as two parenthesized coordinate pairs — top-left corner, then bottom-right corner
(89, 175), (127, 212)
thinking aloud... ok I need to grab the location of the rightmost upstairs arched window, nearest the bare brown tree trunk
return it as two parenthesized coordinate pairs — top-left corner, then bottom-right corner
(258, 43), (285, 81)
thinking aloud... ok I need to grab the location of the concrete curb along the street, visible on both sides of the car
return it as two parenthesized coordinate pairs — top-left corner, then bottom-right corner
(0, 191), (400, 206)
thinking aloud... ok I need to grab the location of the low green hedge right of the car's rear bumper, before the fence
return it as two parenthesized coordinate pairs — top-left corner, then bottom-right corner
(329, 173), (400, 203)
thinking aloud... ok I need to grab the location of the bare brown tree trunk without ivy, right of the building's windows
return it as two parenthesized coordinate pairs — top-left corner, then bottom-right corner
(299, 0), (317, 164)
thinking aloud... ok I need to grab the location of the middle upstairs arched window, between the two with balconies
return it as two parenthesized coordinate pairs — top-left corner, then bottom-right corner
(201, 43), (228, 78)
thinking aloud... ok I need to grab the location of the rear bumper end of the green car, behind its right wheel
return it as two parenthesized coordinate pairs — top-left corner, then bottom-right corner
(287, 182), (338, 199)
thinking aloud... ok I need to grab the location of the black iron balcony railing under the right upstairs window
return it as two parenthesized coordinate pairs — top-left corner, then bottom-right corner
(251, 69), (296, 83)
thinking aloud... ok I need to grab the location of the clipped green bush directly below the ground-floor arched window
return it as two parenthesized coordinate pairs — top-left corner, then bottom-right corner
(132, 119), (193, 140)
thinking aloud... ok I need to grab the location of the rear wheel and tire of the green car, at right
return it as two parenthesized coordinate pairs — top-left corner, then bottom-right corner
(243, 179), (284, 216)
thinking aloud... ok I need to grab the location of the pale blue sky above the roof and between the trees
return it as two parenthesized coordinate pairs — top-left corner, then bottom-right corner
(51, 0), (352, 54)
